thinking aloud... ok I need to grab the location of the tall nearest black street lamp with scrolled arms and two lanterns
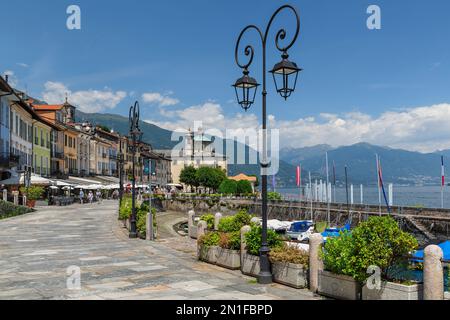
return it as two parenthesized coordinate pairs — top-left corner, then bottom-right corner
(233, 5), (301, 284)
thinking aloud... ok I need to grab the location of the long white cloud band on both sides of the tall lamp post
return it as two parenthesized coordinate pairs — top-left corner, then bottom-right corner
(148, 102), (450, 152)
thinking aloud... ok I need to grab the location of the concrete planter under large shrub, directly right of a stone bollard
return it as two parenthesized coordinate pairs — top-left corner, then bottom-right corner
(318, 271), (361, 300)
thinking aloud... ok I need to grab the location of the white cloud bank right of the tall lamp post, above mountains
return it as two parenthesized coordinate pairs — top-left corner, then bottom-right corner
(270, 103), (450, 152)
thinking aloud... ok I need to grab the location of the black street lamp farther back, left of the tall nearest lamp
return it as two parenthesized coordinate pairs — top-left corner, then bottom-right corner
(129, 101), (142, 238)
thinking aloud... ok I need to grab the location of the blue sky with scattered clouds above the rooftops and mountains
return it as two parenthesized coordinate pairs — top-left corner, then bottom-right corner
(0, 0), (450, 151)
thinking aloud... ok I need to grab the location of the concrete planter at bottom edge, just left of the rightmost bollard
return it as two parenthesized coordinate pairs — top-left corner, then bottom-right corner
(362, 281), (423, 300)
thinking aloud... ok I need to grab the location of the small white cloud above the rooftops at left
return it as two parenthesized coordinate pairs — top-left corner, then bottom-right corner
(42, 81), (127, 113)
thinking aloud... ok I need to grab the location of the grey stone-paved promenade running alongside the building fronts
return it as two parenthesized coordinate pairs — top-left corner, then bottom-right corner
(0, 201), (324, 300)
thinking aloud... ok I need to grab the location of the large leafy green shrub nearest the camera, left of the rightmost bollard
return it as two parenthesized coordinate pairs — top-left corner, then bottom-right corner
(322, 217), (418, 283)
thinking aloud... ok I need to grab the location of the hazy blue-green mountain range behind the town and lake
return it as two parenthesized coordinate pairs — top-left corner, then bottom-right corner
(75, 110), (450, 188)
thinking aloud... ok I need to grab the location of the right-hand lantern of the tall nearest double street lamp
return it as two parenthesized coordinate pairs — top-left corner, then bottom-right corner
(269, 52), (302, 100)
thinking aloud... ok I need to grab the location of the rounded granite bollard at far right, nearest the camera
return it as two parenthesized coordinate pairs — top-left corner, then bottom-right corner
(423, 245), (444, 300)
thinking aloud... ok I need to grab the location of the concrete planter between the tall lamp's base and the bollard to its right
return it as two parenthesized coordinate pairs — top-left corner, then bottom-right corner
(272, 262), (308, 289)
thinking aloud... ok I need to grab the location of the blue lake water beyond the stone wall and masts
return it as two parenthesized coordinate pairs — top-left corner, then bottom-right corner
(276, 185), (450, 209)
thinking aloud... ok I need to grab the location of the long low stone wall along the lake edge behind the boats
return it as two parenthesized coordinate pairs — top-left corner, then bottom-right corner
(162, 198), (450, 243)
